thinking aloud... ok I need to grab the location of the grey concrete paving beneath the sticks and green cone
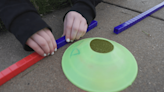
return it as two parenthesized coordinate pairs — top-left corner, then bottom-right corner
(0, 0), (164, 92)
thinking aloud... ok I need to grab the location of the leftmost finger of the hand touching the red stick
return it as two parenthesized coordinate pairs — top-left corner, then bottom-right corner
(26, 38), (46, 56)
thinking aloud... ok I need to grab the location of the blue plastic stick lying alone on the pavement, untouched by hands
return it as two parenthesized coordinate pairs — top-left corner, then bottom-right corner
(114, 2), (164, 34)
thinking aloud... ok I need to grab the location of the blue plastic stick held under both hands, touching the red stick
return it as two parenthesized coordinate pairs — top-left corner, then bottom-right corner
(56, 20), (97, 49)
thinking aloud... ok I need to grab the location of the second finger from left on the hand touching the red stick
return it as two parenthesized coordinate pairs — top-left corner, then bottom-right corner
(31, 33), (50, 54)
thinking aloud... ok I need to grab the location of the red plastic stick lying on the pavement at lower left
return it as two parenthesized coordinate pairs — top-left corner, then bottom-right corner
(0, 52), (44, 86)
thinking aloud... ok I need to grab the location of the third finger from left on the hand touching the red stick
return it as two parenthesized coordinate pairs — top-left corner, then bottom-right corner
(37, 29), (54, 53)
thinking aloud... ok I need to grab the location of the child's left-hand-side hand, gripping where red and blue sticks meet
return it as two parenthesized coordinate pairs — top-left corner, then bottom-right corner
(26, 28), (57, 56)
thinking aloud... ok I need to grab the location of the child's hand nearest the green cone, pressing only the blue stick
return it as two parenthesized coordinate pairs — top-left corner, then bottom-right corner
(63, 11), (88, 42)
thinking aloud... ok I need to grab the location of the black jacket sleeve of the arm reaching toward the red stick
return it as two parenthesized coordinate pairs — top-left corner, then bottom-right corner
(0, 0), (51, 50)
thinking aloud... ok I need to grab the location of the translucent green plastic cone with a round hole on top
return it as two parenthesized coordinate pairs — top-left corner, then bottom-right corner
(62, 37), (138, 92)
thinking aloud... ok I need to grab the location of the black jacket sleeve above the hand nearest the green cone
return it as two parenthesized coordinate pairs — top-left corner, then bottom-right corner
(64, 0), (102, 25)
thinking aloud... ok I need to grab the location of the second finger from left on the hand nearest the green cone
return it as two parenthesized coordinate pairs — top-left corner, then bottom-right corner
(71, 18), (81, 41)
